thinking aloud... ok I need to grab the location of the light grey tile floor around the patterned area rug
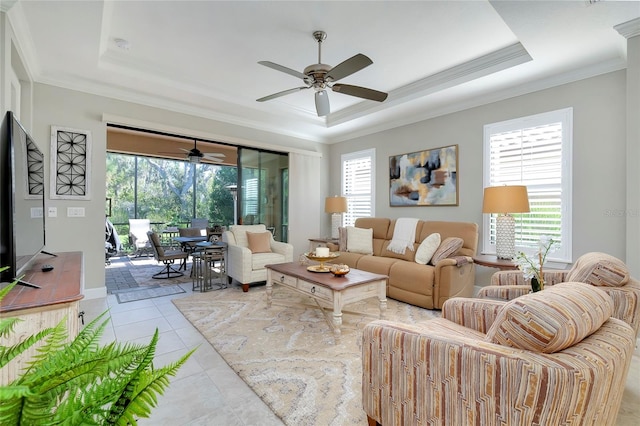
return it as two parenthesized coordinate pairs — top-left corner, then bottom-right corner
(80, 283), (640, 426)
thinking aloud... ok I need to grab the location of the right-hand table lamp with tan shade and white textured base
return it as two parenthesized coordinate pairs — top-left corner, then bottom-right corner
(482, 185), (530, 259)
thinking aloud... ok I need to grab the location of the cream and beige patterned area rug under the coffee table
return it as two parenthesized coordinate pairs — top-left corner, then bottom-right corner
(173, 286), (440, 426)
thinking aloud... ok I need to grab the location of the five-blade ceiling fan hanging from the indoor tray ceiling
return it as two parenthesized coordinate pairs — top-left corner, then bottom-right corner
(257, 31), (387, 117)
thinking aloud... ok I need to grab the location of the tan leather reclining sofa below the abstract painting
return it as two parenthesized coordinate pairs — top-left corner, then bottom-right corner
(332, 217), (478, 309)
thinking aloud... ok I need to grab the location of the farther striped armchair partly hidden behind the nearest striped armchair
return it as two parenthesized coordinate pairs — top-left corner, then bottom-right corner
(478, 252), (640, 336)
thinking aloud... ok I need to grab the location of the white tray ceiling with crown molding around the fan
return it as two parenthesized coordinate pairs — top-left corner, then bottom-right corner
(4, 0), (640, 142)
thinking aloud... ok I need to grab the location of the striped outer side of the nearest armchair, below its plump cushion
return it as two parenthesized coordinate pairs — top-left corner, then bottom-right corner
(362, 318), (634, 426)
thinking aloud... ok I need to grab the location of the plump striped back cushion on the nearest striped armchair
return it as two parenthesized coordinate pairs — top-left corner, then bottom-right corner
(485, 282), (613, 353)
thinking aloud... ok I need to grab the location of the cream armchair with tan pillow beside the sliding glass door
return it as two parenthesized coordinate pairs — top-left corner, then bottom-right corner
(222, 225), (293, 292)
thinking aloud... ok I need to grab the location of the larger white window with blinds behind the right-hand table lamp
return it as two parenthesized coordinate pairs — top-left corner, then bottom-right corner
(483, 108), (573, 262)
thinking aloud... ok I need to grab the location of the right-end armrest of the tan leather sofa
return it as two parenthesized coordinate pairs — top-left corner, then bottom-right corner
(433, 256), (476, 309)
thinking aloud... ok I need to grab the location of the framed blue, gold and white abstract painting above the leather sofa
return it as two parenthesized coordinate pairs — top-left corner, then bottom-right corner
(389, 145), (458, 207)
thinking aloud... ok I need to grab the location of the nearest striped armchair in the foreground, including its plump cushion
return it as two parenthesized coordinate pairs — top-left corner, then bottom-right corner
(362, 283), (635, 426)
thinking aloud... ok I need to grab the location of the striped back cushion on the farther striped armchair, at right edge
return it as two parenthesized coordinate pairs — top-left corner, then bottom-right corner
(566, 253), (629, 287)
